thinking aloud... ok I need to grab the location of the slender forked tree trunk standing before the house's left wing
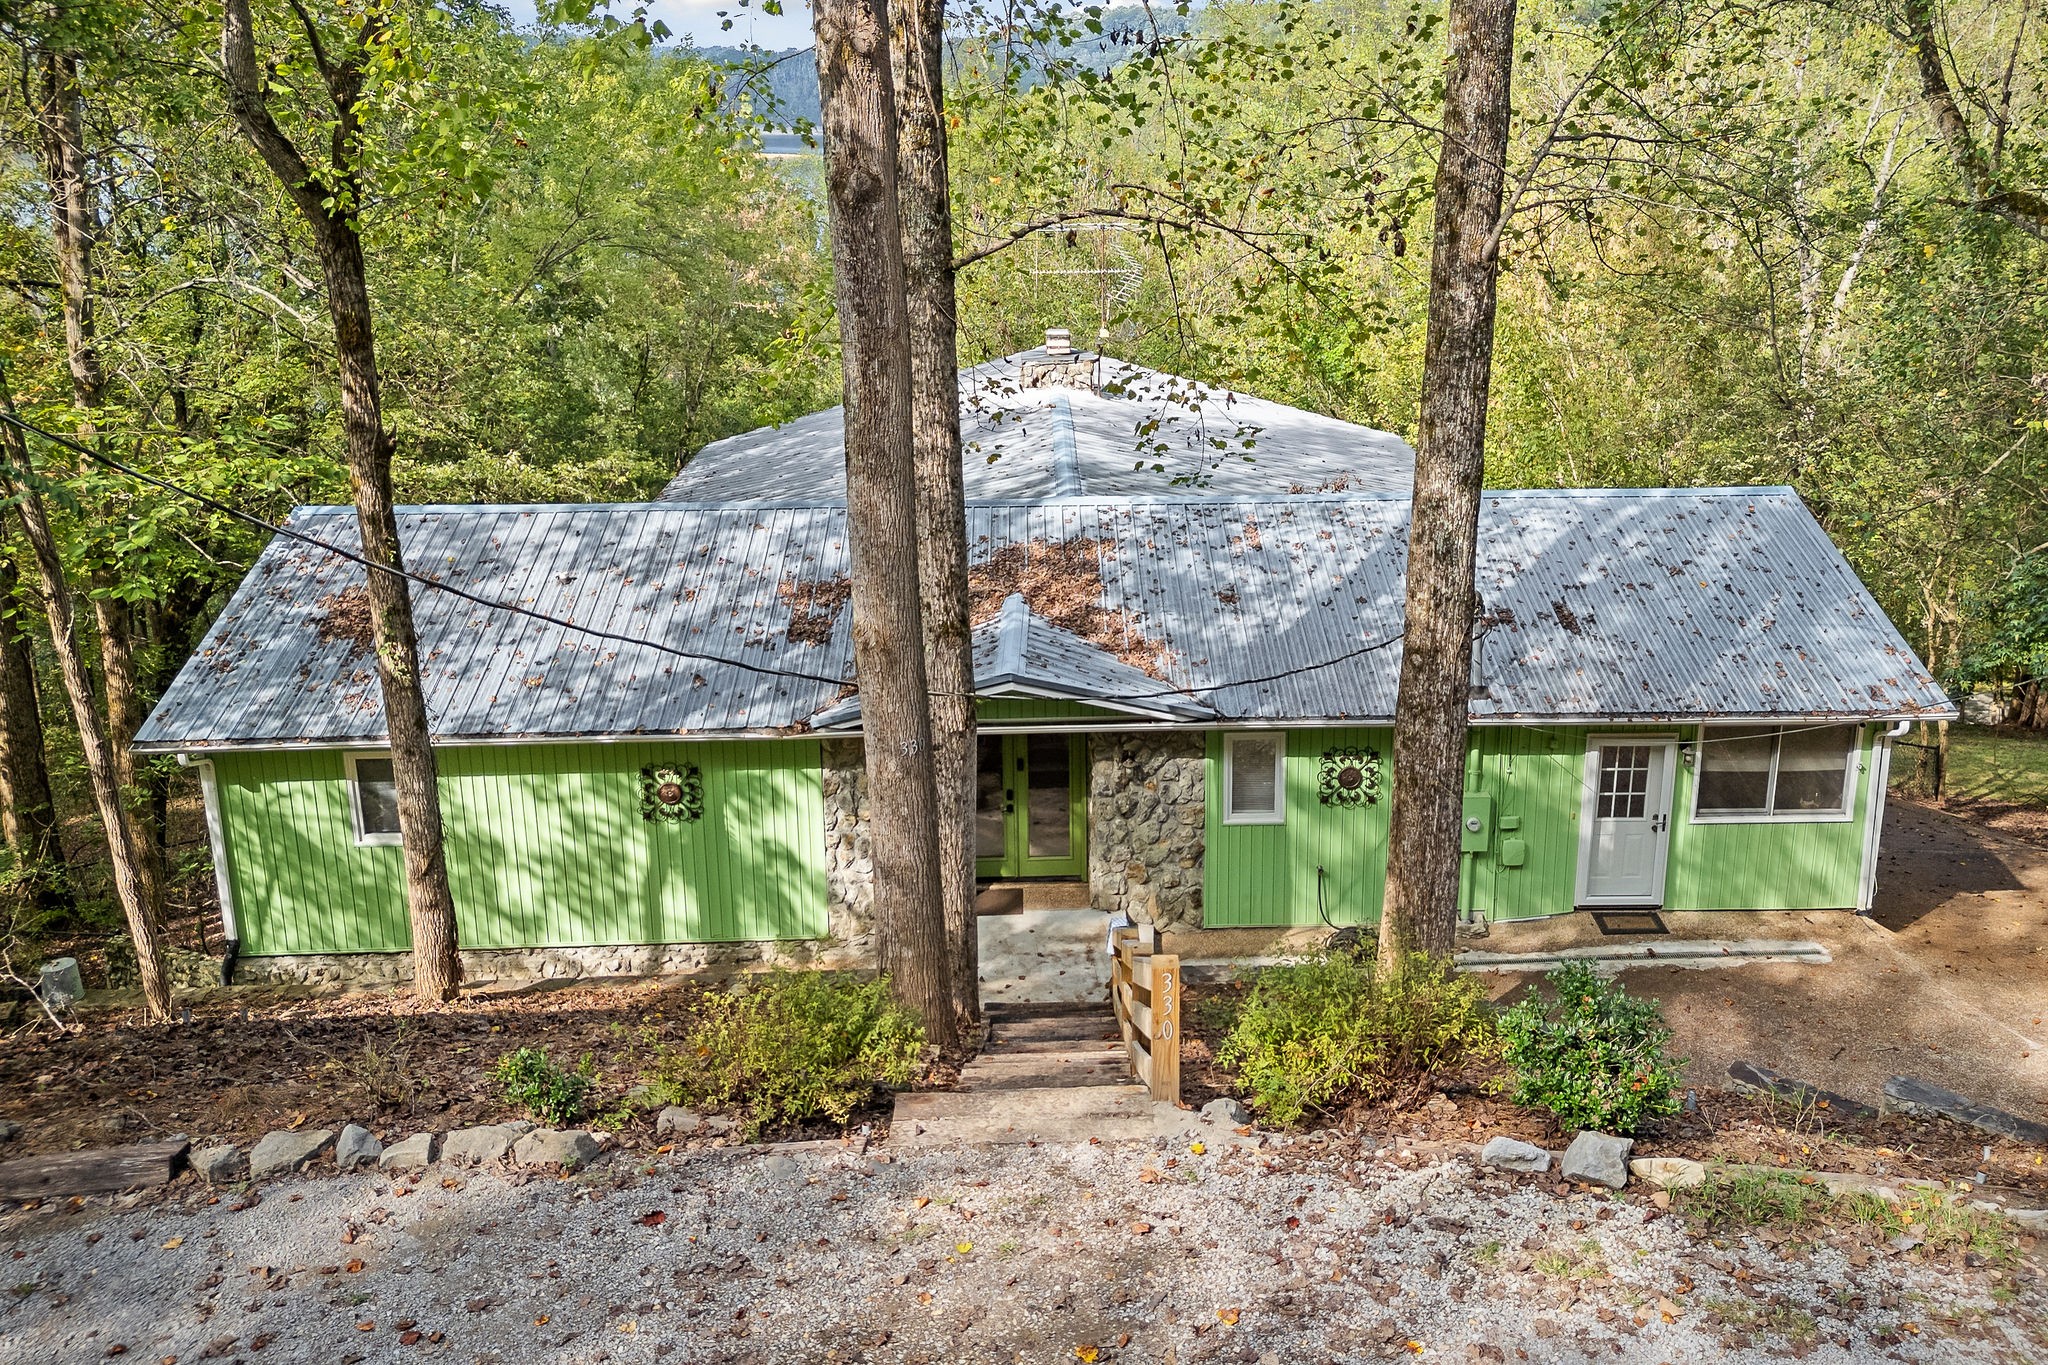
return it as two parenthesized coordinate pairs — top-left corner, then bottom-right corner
(221, 0), (463, 1001)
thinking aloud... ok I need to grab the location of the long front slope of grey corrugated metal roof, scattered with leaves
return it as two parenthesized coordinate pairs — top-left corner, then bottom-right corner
(139, 487), (1954, 749)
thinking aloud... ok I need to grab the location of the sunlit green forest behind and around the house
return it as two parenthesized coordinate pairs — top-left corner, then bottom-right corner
(0, 0), (2048, 980)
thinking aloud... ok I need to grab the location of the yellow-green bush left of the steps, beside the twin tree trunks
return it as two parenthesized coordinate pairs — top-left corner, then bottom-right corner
(653, 972), (924, 1138)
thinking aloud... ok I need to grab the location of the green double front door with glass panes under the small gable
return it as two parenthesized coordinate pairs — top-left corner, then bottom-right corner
(975, 735), (1087, 878)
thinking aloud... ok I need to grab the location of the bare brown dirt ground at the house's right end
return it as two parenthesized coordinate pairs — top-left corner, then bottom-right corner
(1485, 798), (2048, 1121)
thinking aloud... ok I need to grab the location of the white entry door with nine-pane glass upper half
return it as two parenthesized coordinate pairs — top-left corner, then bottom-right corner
(1579, 735), (1677, 905)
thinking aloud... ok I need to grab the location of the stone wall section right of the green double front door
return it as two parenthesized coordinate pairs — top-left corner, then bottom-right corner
(1087, 733), (1208, 929)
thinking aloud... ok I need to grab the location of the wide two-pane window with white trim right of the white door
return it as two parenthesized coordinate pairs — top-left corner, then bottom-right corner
(1694, 724), (1858, 821)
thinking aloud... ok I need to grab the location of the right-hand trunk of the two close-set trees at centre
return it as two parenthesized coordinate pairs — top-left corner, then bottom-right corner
(893, 0), (981, 1023)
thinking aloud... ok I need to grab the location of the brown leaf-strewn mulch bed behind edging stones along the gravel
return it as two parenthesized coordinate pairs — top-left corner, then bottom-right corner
(0, 980), (2048, 1197)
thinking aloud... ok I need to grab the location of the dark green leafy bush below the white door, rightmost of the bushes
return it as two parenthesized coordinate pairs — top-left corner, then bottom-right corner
(1501, 962), (1683, 1134)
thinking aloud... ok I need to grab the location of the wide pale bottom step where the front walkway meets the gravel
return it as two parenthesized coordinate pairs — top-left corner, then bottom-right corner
(889, 1085), (1159, 1148)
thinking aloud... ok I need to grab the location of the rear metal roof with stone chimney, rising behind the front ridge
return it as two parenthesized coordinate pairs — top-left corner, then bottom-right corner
(662, 352), (1415, 503)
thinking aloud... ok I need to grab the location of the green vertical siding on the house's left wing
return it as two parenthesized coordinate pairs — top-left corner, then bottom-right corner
(215, 739), (825, 956)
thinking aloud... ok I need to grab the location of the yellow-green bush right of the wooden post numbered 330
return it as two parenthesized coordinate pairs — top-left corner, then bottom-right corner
(1217, 954), (1493, 1124)
